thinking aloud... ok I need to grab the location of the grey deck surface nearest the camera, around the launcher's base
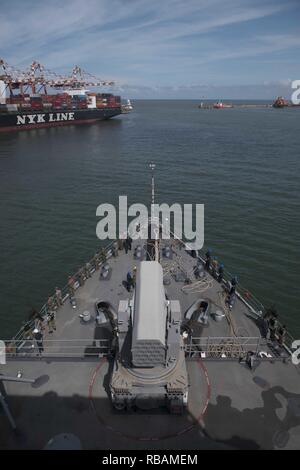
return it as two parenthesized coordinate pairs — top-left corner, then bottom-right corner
(0, 361), (300, 449)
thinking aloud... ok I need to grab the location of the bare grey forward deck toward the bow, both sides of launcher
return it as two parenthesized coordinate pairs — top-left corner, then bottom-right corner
(7, 242), (260, 344)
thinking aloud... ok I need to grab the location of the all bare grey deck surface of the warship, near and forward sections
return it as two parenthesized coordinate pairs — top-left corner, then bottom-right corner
(0, 244), (300, 449)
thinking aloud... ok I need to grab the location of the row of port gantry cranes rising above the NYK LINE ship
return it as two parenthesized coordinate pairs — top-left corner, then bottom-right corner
(0, 59), (115, 96)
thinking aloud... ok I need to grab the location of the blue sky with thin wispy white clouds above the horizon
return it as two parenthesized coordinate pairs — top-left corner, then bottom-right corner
(0, 0), (300, 99)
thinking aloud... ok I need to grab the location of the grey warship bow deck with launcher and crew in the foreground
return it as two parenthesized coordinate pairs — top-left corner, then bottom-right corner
(0, 165), (300, 450)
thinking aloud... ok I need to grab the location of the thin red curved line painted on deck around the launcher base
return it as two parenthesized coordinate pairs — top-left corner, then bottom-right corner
(89, 358), (211, 441)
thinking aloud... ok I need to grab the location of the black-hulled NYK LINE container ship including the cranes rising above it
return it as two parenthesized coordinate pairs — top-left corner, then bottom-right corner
(0, 60), (122, 132)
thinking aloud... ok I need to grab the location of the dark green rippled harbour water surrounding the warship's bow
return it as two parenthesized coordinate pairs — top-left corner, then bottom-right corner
(0, 101), (300, 339)
